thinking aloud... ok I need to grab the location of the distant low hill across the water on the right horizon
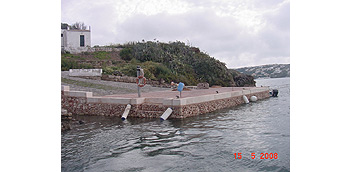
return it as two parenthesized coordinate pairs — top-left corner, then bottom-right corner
(236, 64), (290, 79)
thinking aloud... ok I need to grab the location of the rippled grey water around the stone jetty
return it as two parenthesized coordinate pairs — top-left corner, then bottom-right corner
(61, 78), (290, 172)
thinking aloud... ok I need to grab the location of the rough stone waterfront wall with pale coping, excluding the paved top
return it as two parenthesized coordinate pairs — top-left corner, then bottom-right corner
(61, 86), (270, 118)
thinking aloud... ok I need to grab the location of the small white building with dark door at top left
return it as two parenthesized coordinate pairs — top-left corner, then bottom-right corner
(61, 27), (91, 54)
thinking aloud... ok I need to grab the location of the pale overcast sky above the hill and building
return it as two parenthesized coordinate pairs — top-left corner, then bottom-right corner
(61, 0), (290, 68)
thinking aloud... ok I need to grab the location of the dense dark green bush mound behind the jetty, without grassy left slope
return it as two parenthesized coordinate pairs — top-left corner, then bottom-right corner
(115, 41), (234, 86)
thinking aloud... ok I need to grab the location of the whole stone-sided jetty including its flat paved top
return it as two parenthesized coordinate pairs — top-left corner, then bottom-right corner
(61, 86), (270, 118)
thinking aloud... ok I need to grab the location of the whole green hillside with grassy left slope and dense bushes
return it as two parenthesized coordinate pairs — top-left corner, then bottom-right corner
(61, 41), (254, 86)
